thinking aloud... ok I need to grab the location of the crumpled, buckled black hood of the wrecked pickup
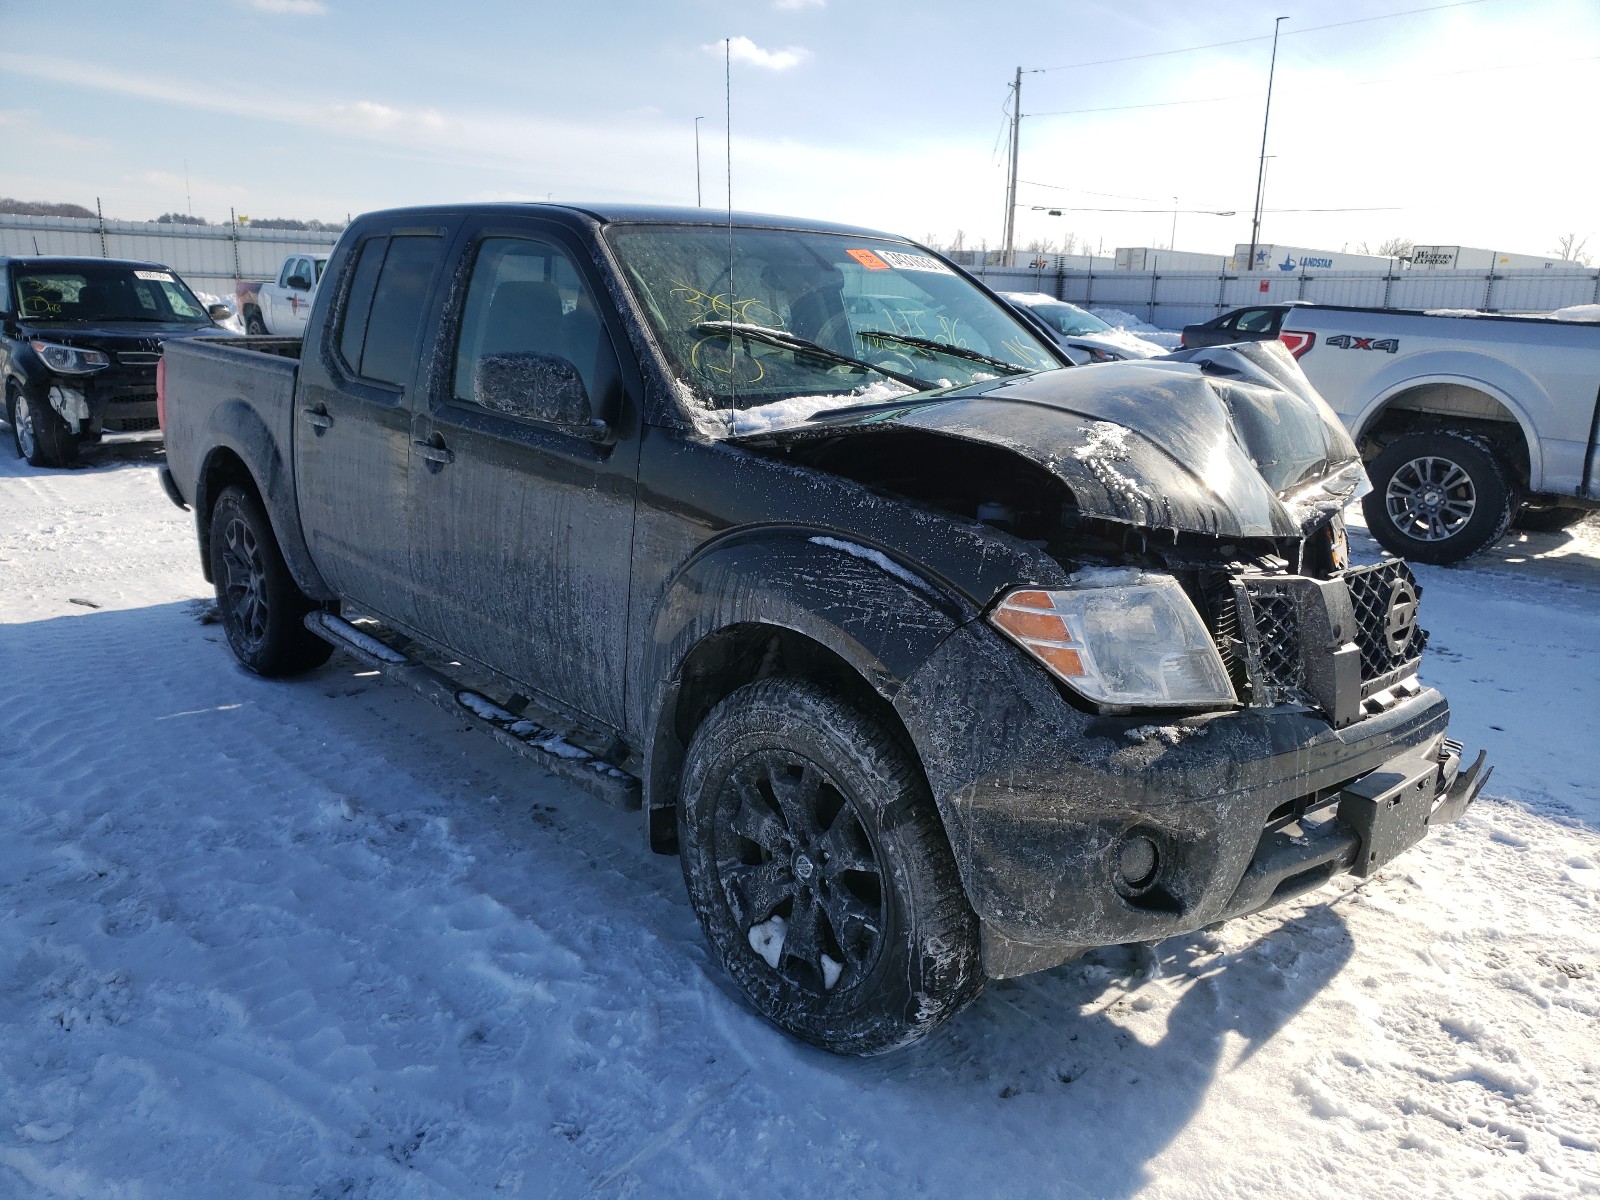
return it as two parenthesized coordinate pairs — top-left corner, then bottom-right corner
(730, 342), (1366, 538)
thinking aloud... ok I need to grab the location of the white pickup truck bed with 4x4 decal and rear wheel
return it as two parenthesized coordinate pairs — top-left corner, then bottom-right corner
(1278, 304), (1600, 563)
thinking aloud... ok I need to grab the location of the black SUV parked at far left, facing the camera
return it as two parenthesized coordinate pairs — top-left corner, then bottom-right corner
(0, 258), (232, 467)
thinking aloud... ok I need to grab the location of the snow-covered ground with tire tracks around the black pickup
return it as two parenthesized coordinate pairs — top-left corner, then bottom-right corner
(0, 430), (1600, 1200)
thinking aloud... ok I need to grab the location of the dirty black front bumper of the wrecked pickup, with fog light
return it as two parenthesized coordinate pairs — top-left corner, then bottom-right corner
(896, 626), (1488, 978)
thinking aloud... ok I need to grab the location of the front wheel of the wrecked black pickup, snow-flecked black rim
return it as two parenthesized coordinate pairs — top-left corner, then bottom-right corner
(678, 678), (984, 1054)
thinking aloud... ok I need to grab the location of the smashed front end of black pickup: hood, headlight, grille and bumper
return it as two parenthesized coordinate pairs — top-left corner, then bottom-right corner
(733, 344), (1488, 976)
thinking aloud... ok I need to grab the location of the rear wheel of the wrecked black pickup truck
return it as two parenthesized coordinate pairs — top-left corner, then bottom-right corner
(210, 486), (333, 677)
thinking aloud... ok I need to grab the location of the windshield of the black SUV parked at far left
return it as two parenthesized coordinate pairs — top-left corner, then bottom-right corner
(11, 262), (211, 325)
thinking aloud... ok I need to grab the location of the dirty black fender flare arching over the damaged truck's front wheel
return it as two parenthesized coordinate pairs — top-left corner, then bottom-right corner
(640, 526), (978, 838)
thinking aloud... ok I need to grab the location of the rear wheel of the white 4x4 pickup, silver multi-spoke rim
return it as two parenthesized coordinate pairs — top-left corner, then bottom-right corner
(1362, 429), (1515, 563)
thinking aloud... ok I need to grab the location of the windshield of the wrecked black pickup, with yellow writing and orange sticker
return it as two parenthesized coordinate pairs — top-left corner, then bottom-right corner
(608, 226), (1061, 425)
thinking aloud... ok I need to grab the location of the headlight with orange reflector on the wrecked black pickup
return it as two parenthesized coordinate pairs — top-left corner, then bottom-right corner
(989, 570), (1238, 709)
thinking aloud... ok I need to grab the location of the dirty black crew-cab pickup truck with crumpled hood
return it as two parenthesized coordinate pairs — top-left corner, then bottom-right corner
(163, 205), (1486, 1053)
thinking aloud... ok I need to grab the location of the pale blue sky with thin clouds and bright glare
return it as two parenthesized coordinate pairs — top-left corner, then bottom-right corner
(0, 0), (1600, 258)
